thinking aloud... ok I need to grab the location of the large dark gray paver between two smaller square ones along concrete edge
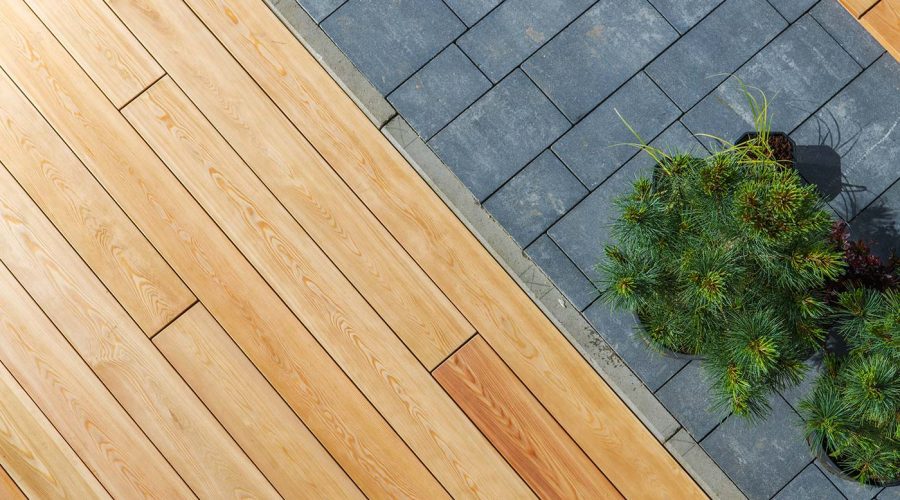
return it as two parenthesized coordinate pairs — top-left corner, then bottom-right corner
(429, 70), (569, 201)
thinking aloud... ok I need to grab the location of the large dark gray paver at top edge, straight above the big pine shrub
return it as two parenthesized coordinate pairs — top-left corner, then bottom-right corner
(647, 0), (787, 110)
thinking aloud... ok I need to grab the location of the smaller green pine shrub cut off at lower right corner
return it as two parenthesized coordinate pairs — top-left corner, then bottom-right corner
(801, 288), (900, 484)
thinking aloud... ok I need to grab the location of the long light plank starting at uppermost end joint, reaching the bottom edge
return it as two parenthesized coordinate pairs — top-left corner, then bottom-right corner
(124, 77), (530, 498)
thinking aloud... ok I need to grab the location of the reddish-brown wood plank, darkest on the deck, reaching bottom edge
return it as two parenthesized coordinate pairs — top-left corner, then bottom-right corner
(434, 336), (622, 499)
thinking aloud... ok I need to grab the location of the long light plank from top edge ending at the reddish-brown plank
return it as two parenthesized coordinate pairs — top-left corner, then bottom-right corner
(100, 0), (474, 369)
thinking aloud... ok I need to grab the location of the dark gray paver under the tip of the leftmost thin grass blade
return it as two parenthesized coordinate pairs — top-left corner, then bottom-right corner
(553, 73), (679, 189)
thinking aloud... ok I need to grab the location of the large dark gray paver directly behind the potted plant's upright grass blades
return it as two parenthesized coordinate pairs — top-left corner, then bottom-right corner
(682, 16), (860, 149)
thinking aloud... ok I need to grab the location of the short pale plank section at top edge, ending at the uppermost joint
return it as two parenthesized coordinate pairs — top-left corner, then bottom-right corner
(25, 0), (163, 108)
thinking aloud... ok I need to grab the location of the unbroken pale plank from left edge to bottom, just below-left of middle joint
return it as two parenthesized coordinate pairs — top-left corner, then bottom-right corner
(0, 152), (278, 498)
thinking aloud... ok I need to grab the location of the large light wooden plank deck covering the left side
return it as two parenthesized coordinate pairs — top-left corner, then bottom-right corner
(0, 0), (704, 499)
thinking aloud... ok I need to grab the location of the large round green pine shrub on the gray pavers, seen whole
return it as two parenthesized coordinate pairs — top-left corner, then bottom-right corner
(598, 140), (843, 417)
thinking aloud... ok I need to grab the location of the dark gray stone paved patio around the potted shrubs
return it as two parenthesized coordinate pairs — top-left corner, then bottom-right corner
(288, 0), (900, 500)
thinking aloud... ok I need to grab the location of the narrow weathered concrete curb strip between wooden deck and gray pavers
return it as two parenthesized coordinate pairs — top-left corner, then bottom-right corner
(265, 0), (745, 499)
